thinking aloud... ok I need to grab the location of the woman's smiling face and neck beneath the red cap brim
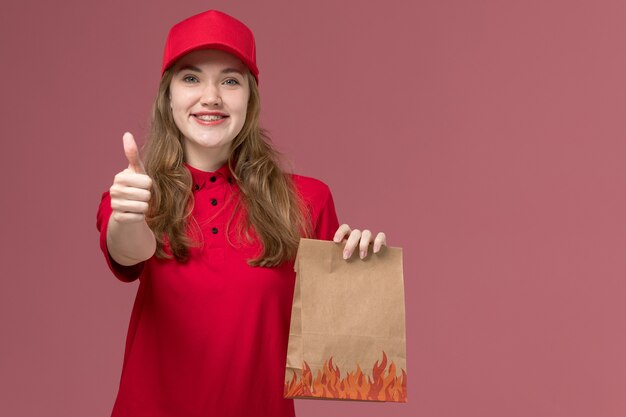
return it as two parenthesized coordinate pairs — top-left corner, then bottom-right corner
(170, 49), (250, 165)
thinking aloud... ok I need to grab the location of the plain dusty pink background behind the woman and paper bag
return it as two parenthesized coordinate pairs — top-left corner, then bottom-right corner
(0, 0), (626, 417)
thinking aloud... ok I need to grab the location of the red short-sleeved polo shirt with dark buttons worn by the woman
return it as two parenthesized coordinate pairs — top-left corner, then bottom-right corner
(97, 162), (338, 417)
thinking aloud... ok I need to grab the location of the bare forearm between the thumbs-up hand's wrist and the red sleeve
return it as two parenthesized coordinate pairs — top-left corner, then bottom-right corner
(107, 216), (156, 266)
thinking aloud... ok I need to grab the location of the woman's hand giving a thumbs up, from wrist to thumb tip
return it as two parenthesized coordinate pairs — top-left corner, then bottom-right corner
(109, 132), (152, 223)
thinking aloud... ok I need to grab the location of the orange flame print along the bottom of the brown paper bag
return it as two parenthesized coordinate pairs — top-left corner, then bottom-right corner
(284, 351), (406, 402)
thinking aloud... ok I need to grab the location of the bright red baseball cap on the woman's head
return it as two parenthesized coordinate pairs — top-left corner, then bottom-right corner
(161, 10), (259, 83)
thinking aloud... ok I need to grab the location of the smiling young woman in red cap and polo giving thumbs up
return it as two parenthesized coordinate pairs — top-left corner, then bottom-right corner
(97, 11), (385, 417)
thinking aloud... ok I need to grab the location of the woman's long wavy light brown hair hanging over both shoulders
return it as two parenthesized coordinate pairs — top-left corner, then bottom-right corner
(140, 66), (311, 267)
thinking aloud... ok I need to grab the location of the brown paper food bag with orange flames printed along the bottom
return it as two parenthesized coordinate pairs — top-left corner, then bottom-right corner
(284, 239), (407, 402)
